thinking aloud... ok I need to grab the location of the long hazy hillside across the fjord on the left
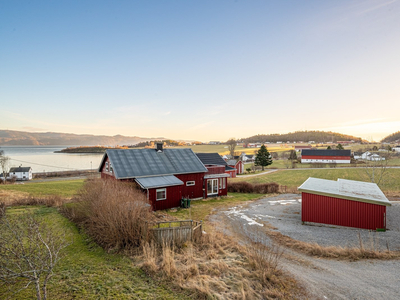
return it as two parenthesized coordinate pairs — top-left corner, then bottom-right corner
(0, 130), (159, 146)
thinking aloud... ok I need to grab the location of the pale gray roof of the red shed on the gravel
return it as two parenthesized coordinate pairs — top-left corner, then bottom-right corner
(298, 177), (391, 206)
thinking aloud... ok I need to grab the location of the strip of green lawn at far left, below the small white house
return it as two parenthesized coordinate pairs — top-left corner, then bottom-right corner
(0, 179), (84, 197)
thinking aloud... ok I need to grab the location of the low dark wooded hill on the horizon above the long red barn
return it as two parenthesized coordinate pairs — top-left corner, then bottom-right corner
(242, 131), (362, 143)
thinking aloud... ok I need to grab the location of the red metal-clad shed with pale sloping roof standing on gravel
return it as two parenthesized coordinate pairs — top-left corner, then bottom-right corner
(298, 177), (391, 230)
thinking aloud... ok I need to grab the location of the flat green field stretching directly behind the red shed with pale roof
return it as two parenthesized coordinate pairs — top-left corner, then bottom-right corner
(229, 168), (400, 192)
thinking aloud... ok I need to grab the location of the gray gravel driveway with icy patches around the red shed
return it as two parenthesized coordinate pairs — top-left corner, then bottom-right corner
(210, 194), (400, 299)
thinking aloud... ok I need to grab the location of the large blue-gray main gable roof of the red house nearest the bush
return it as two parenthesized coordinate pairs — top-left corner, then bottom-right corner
(99, 148), (208, 179)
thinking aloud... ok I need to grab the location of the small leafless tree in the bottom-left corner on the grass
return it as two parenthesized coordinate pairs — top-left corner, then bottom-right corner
(0, 209), (69, 300)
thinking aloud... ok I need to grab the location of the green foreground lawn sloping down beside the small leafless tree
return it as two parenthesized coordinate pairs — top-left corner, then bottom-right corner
(0, 207), (190, 299)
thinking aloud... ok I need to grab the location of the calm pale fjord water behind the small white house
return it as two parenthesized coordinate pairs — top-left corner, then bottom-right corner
(0, 146), (103, 173)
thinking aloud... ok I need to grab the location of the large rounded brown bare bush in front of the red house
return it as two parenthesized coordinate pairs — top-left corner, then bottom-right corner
(62, 179), (154, 250)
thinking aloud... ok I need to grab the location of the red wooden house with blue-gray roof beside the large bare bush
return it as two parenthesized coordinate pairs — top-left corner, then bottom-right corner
(99, 143), (227, 210)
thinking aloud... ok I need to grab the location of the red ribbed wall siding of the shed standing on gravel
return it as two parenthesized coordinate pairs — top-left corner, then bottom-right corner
(301, 193), (386, 230)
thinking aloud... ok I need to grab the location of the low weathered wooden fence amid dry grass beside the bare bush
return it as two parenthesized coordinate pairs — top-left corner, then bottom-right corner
(150, 220), (203, 245)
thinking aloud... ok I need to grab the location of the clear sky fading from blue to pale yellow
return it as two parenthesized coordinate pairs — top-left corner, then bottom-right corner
(0, 0), (400, 142)
